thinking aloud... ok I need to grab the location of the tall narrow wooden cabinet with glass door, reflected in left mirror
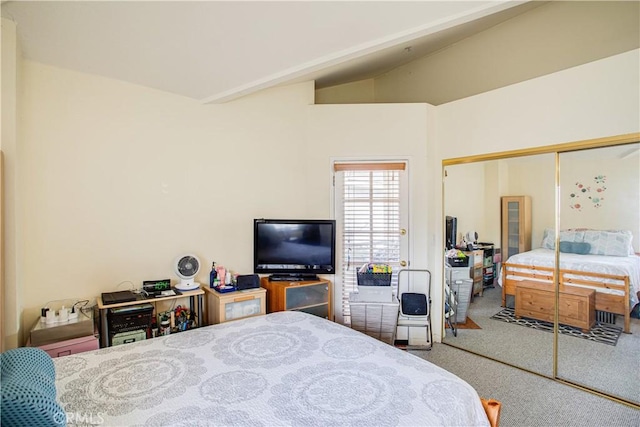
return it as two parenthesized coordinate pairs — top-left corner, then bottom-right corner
(501, 196), (531, 261)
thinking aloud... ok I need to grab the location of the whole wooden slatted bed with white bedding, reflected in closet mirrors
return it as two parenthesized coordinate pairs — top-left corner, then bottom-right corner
(498, 230), (640, 333)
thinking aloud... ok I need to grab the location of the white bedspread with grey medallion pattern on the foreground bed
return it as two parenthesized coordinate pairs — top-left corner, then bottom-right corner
(54, 311), (489, 427)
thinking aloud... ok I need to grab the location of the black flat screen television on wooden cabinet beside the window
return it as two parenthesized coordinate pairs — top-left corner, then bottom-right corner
(253, 219), (336, 280)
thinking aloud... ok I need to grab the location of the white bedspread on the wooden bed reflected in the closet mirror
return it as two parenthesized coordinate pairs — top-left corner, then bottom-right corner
(498, 248), (640, 308)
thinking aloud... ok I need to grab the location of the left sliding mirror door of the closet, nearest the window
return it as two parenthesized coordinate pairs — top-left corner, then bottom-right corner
(443, 153), (555, 376)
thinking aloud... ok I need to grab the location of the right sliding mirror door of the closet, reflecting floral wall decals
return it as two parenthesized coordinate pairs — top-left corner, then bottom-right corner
(557, 143), (640, 403)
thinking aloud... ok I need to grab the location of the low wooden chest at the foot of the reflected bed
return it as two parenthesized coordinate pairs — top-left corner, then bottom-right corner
(515, 280), (596, 332)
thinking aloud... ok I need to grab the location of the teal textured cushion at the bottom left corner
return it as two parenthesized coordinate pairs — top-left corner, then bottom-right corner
(0, 347), (66, 427)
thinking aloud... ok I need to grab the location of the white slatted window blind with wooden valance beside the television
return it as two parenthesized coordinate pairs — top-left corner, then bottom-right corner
(335, 163), (406, 324)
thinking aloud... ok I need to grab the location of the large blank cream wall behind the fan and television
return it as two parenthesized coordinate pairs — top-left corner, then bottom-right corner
(17, 61), (328, 342)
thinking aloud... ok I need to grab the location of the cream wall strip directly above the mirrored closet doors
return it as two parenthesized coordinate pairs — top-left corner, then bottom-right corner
(437, 49), (640, 158)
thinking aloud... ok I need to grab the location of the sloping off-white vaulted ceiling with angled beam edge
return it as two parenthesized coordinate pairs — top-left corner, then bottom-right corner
(2, 0), (637, 102)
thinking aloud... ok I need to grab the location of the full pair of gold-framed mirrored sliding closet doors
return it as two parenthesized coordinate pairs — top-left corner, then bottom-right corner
(443, 134), (640, 404)
